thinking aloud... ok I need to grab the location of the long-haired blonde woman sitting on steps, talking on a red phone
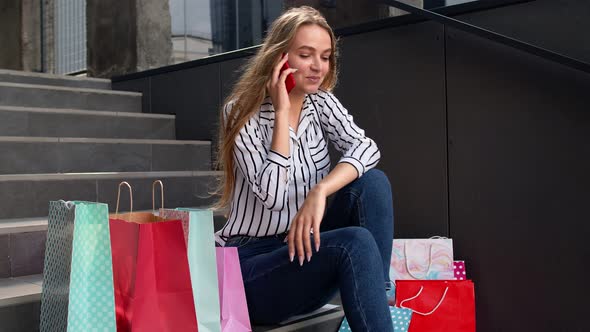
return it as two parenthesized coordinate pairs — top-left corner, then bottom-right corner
(216, 7), (393, 332)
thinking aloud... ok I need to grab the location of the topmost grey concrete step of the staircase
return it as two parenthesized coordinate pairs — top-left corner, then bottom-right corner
(0, 69), (111, 90)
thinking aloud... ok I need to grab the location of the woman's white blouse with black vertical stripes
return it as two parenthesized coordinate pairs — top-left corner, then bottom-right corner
(216, 90), (381, 243)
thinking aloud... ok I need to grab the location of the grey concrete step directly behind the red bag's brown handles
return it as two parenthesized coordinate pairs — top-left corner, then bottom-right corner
(0, 171), (221, 219)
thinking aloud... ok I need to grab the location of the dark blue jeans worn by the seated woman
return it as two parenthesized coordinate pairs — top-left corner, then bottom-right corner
(226, 169), (393, 332)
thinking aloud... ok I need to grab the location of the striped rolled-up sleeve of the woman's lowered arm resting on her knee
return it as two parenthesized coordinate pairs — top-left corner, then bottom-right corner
(321, 92), (381, 177)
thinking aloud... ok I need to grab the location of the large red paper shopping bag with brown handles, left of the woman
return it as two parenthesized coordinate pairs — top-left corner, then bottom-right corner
(109, 183), (197, 332)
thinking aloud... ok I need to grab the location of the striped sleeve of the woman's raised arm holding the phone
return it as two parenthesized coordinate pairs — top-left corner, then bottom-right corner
(226, 106), (291, 211)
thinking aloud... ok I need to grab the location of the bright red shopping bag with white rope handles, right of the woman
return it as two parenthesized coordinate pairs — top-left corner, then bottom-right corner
(395, 280), (475, 332)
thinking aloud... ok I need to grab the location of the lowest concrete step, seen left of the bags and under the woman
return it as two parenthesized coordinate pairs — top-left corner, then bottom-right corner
(0, 274), (344, 332)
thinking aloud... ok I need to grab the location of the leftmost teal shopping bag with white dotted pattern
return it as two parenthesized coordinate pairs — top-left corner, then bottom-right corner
(40, 201), (116, 332)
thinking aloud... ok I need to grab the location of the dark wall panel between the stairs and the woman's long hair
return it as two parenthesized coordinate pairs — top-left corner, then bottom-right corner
(151, 63), (220, 140)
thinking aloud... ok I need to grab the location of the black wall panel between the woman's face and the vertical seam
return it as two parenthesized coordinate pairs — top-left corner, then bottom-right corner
(335, 23), (448, 238)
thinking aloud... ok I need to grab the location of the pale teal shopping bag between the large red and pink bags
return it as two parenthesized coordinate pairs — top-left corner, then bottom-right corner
(160, 208), (221, 332)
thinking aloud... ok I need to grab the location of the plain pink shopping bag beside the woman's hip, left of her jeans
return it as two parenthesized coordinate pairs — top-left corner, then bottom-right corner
(215, 247), (252, 332)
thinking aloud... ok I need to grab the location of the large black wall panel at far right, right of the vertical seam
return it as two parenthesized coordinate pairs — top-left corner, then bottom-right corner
(446, 30), (590, 331)
